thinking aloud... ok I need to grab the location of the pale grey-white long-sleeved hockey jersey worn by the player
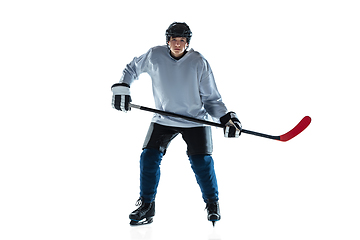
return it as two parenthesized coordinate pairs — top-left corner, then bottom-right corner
(120, 45), (227, 127)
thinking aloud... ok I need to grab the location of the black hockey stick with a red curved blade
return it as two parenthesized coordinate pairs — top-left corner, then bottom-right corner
(129, 103), (311, 142)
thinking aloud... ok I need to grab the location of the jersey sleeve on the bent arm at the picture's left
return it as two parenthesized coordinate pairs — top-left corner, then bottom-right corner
(120, 49), (152, 86)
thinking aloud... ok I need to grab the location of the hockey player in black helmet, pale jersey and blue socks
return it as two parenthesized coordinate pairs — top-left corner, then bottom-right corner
(111, 22), (242, 225)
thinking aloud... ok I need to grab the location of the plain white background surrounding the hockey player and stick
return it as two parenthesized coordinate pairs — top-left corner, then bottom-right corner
(0, 0), (360, 239)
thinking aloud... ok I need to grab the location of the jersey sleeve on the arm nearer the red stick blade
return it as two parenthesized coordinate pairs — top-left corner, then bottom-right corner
(200, 60), (228, 121)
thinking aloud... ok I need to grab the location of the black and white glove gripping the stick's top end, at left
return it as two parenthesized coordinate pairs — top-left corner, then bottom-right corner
(111, 83), (131, 112)
